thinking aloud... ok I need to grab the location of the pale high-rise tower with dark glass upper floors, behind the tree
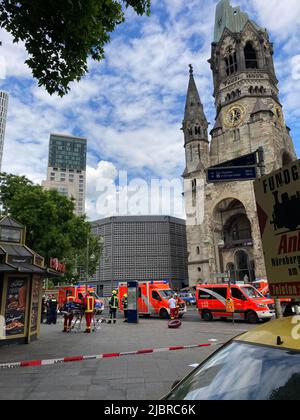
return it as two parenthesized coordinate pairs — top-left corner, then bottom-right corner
(42, 134), (87, 216)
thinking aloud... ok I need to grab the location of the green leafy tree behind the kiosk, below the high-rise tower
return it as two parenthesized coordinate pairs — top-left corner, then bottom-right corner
(0, 173), (100, 278)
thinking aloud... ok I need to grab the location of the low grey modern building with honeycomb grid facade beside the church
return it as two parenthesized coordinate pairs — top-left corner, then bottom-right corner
(92, 216), (188, 295)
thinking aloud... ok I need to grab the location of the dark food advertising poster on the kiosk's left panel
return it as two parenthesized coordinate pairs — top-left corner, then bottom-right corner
(5, 278), (28, 337)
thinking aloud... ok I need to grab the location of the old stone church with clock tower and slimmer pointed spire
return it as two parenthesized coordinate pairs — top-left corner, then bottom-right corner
(182, 0), (296, 286)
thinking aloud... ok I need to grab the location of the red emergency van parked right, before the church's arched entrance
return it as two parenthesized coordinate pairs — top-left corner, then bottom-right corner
(197, 284), (275, 324)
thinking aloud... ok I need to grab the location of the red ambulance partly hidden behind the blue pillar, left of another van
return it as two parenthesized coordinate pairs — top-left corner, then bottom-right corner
(119, 281), (187, 319)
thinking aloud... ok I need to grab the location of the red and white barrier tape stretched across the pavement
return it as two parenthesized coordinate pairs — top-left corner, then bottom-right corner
(0, 340), (221, 370)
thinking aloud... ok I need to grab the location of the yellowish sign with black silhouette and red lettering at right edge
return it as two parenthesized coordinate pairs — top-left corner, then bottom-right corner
(254, 160), (300, 298)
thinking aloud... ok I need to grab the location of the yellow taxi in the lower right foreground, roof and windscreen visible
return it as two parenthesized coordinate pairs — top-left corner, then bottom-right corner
(164, 316), (300, 401)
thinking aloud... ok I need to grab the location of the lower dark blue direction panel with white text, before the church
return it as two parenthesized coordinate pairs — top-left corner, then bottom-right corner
(207, 166), (257, 183)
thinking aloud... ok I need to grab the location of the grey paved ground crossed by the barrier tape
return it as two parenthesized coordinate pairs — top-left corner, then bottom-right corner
(0, 309), (253, 400)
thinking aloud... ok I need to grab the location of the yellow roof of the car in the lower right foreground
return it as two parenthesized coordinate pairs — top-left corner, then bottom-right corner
(235, 316), (300, 351)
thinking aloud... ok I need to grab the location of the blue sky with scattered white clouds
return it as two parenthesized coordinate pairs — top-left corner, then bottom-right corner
(0, 0), (300, 220)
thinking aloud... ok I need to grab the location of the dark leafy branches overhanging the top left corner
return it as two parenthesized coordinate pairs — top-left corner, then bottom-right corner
(0, 0), (150, 96)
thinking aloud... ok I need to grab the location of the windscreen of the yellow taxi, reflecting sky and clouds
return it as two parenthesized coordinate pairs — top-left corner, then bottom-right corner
(167, 342), (300, 401)
